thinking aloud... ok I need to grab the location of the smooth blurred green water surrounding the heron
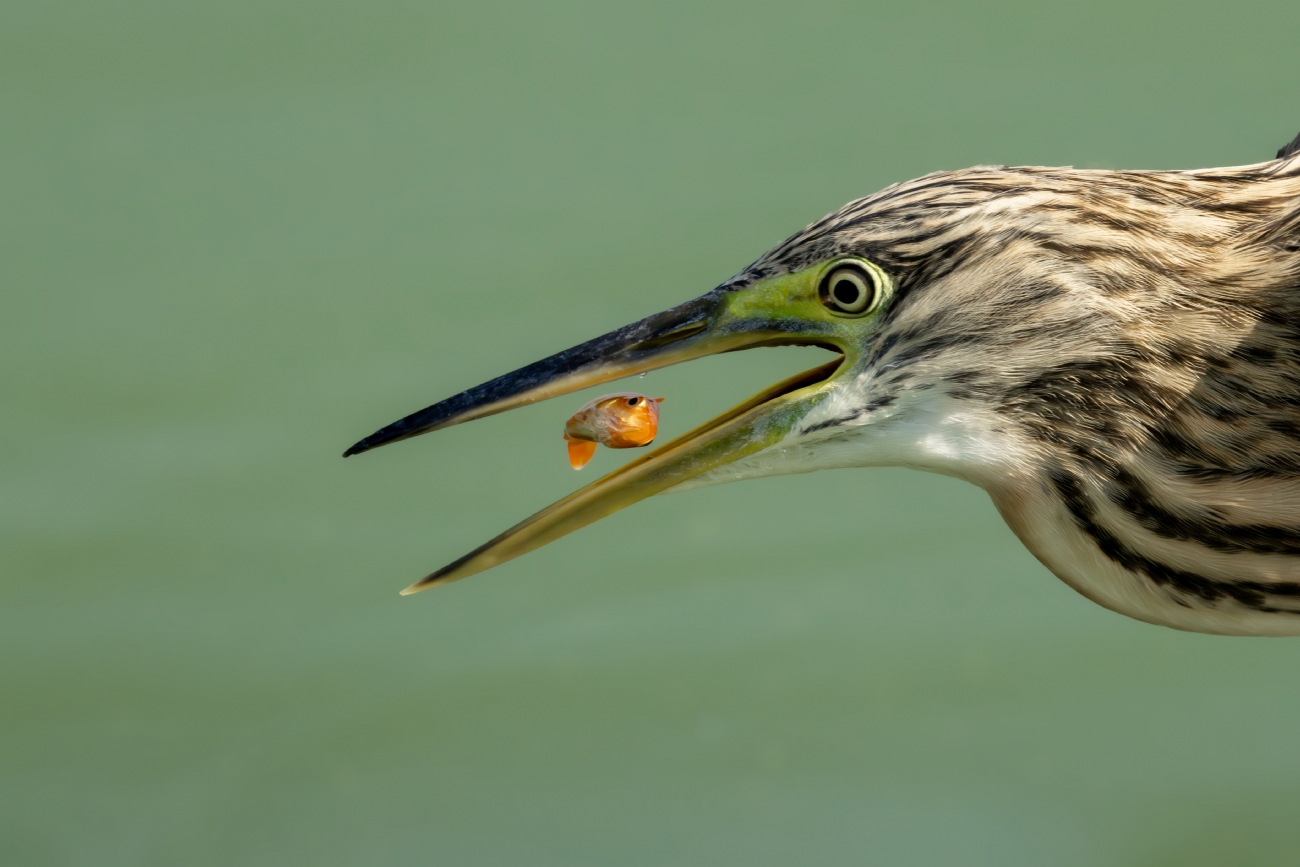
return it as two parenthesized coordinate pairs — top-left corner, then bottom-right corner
(0, 0), (1300, 867)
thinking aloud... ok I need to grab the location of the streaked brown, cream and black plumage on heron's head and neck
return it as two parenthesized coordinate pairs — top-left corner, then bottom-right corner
(724, 153), (1300, 634)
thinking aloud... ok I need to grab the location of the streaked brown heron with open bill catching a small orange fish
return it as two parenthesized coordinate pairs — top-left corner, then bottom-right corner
(345, 135), (1300, 636)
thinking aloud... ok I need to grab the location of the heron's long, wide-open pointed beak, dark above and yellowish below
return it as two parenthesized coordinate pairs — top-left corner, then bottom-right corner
(343, 289), (846, 595)
